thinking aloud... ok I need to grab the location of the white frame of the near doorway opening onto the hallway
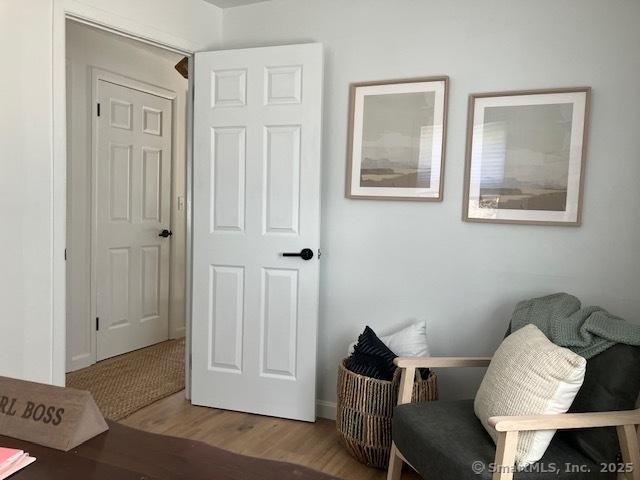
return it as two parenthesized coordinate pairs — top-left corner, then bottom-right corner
(49, 0), (195, 388)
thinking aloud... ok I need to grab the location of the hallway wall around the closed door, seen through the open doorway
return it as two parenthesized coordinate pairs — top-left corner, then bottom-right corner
(66, 21), (187, 371)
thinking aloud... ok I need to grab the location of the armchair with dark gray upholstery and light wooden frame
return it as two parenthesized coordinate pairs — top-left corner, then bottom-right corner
(387, 345), (640, 480)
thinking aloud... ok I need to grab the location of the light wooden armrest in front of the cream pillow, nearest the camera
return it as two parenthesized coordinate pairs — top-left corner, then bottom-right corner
(489, 409), (640, 432)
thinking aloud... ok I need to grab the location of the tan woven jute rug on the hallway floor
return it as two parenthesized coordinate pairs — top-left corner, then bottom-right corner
(67, 338), (184, 420)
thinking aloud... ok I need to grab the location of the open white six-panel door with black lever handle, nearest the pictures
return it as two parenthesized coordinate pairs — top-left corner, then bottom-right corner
(192, 44), (323, 421)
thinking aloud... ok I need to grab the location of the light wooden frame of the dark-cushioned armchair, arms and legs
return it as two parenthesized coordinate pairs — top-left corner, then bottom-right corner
(387, 357), (640, 480)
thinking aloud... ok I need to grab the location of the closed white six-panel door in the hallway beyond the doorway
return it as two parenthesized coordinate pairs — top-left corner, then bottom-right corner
(93, 80), (172, 360)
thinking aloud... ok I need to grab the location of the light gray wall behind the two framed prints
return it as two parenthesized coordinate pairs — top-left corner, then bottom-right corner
(223, 0), (640, 412)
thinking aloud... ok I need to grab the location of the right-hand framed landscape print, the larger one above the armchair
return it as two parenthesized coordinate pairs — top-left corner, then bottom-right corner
(463, 87), (591, 226)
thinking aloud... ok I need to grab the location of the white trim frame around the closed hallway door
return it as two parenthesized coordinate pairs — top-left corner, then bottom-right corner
(87, 67), (178, 364)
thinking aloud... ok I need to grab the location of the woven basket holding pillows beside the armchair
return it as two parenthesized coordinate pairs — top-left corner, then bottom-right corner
(336, 360), (438, 468)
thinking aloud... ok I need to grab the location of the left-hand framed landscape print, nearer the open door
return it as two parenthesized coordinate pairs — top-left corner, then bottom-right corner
(346, 77), (449, 201)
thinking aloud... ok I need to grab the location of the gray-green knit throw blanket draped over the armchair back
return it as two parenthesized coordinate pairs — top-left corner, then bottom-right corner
(511, 293), (640, 359)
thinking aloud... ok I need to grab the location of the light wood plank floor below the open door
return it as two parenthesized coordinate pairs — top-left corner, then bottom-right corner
(120, 392), (420, 480)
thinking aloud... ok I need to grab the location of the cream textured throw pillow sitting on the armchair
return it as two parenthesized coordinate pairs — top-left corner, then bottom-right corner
(474, 325), (587, 469)
